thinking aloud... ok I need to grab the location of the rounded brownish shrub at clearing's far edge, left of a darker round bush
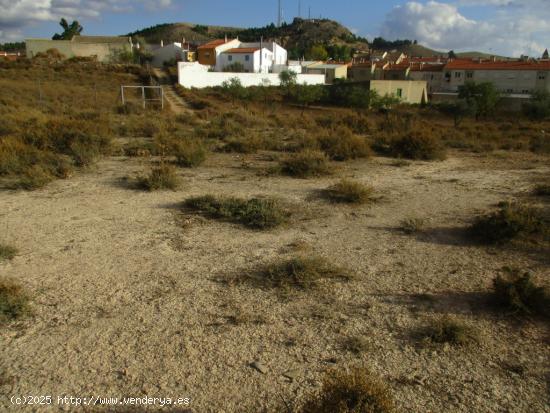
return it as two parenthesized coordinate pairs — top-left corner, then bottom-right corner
(319, 127), (371, 161)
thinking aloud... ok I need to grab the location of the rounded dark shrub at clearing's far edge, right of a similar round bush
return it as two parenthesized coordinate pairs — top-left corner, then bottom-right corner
(389, 131), (445, 161)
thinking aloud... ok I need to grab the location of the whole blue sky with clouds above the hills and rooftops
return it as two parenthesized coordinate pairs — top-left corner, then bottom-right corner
(0, 0), (550, 56)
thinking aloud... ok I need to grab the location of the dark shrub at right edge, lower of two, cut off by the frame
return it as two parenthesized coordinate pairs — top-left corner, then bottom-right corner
(493, 268), (550, 316)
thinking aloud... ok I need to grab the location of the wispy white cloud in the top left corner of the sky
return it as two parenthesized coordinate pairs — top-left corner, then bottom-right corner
(0, 0), (172, 42)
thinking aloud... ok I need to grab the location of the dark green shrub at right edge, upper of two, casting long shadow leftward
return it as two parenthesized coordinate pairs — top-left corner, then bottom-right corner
(470, 202), (548, 244)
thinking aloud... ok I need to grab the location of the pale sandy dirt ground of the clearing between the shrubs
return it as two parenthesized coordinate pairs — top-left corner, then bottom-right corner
(0, 152), (550, 413)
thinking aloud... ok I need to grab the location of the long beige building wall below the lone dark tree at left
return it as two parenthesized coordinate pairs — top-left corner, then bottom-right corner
(25, 39), (130, 62)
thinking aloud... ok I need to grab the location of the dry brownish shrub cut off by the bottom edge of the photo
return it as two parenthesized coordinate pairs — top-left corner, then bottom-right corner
(300, 368), (395, 413)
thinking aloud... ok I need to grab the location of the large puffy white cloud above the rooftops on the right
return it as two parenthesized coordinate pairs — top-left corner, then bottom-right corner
(382, 0), (550, 56)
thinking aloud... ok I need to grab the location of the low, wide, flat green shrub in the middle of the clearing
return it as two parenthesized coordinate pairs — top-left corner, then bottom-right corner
(184, 195), (289, 229)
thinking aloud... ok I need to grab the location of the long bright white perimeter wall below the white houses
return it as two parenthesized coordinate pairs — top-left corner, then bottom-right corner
(178, 62), (325, 89)
